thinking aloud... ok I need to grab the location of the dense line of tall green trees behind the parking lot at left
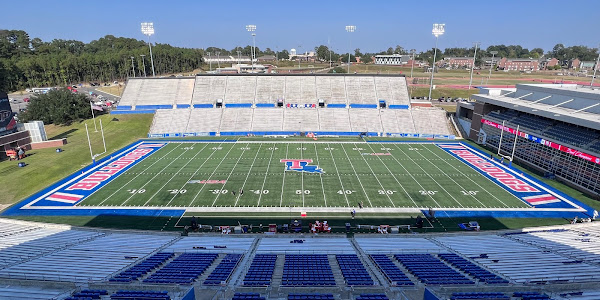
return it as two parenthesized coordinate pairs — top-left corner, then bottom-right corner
(0, 30), (202, 91)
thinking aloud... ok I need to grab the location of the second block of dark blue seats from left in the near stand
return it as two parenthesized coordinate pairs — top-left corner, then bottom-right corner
(144, 253), (218, 284)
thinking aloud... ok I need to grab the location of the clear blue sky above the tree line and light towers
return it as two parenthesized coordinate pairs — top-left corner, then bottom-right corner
(0, 0), (600, 52)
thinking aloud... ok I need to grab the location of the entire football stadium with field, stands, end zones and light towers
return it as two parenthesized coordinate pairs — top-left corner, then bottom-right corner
(0, 2), (600, 300)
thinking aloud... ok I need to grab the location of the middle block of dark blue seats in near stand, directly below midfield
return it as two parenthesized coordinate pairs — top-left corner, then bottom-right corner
(281, 254), (335, 286)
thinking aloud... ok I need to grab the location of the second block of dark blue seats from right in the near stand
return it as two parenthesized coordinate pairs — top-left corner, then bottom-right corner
(394, 254), (474, 285)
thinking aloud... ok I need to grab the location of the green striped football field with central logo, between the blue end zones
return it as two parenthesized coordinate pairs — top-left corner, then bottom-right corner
(77, 142), (529, 211)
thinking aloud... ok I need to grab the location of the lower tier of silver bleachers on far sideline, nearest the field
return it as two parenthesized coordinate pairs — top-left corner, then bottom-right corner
(149, 108), (452, 136)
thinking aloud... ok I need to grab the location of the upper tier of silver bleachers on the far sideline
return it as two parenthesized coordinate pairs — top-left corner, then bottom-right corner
(117, 74), (410, 111)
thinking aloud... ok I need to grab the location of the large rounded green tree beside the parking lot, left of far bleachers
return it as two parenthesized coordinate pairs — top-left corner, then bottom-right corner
(19, 89), (92, 125)
